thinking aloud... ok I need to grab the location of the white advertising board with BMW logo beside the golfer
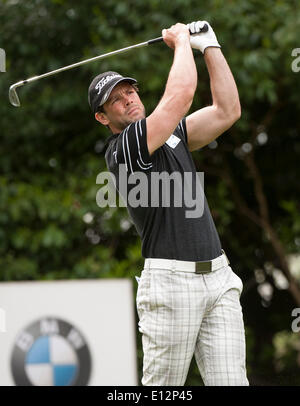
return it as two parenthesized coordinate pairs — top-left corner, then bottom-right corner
(0, 279), (137, 386)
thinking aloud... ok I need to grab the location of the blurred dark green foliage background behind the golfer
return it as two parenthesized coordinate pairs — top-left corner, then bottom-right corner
(0, 0), (300, 385)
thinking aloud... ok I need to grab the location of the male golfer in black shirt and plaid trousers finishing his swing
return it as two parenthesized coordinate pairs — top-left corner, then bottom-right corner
(88, 21), (249, 386)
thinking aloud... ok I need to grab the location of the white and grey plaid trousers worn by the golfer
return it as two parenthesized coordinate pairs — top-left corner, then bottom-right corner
(136, 266), (249, 386)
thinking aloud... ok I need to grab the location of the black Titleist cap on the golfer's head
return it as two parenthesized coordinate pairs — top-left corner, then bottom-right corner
(88, 71), (137, 113)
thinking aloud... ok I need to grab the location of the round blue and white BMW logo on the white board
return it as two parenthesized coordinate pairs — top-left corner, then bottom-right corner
(11, 317), (91, 386)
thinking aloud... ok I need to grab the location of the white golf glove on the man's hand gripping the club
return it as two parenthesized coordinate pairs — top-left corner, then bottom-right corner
(187, 21), (221, 54)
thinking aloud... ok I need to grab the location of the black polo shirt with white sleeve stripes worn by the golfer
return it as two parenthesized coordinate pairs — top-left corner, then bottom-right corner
(105, 118), (222, 261)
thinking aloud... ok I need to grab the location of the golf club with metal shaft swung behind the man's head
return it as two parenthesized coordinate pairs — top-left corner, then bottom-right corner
(8, 24), (208, 107)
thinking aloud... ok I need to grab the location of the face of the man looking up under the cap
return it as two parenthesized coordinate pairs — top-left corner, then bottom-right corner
(95, 82), (145, 133)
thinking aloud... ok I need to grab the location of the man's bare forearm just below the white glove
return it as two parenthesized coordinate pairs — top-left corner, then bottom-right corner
(204, 48), (241, 117)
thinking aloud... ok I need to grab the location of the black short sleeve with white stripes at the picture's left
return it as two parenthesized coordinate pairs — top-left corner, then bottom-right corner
(106, 119), (153, 174)
